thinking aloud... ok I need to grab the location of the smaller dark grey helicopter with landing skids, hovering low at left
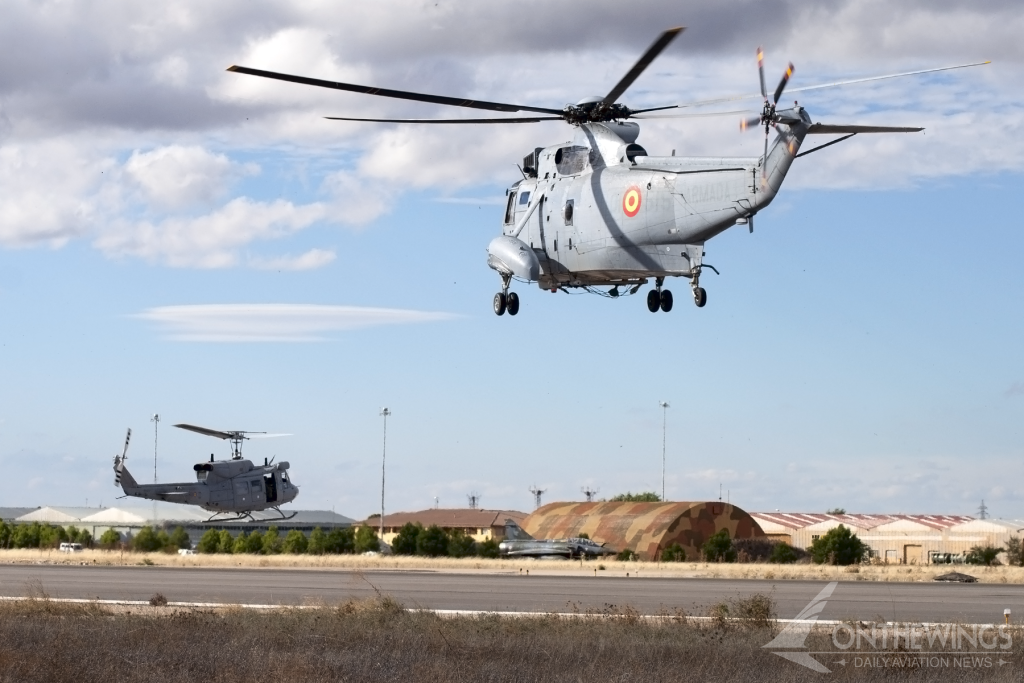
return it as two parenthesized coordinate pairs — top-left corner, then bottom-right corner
(114, 424), (299, 521)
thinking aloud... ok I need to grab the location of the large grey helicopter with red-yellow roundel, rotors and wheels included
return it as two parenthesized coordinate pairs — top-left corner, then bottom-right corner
(228, 28), (989, 315)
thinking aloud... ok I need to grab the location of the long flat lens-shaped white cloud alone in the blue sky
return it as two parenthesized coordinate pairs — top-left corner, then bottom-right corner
(136, 303), (457, 342)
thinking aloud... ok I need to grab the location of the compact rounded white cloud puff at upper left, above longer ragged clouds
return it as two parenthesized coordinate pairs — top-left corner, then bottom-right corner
(124, 144), (259, 209)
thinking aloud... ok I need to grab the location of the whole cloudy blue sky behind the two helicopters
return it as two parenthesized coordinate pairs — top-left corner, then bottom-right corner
(0, 0), (1024, 518)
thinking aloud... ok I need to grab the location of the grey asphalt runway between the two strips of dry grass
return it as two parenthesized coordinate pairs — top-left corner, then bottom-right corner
(0, 564), (1024, 623)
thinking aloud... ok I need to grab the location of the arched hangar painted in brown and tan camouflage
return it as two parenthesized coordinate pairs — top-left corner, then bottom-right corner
(522, 501), (765, 560)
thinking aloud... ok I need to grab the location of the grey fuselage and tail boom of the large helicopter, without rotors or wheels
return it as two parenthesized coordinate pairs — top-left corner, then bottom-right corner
(487, 113), (811, 290)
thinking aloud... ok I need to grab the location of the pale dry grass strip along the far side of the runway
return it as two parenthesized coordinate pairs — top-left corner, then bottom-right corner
(0, 550), (1024, 584)
